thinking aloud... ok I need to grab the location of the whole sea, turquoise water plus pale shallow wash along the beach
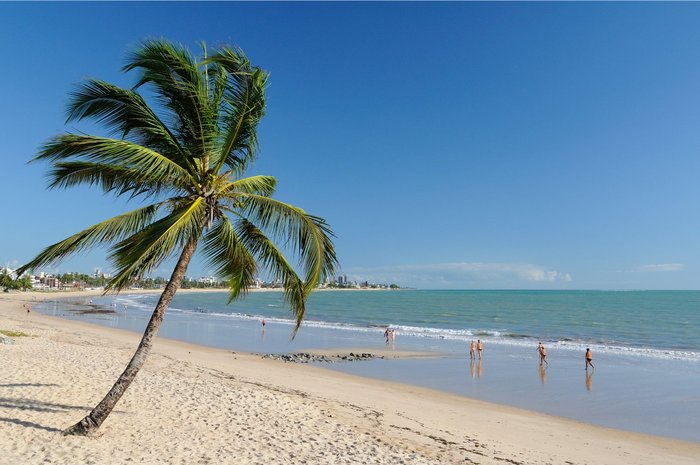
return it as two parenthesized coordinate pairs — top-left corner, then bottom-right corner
(36, 290), (700, 442)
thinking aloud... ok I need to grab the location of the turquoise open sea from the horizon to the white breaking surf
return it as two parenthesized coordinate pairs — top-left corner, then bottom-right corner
(115, 290), (700, 361)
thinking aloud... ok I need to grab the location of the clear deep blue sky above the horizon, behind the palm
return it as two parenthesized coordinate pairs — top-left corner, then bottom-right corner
(0, 3), (700, 289)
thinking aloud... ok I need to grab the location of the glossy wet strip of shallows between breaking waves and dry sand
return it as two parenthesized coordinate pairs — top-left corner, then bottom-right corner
(16, 293), (700, 443)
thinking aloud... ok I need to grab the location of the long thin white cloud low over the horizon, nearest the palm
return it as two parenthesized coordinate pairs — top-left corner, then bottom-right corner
(347, 262), (572, 289)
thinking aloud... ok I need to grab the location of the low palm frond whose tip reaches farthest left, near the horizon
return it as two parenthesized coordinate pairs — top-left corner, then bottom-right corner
(17, 202), (165, 275)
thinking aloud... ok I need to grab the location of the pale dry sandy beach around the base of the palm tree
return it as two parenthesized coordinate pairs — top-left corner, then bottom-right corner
(0, 292), (700, 464)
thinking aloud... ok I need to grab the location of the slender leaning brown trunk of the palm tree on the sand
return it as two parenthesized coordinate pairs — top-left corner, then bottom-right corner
(63, 238), (198, 436)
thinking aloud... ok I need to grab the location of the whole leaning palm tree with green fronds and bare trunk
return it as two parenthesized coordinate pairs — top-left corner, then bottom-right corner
(17, 40), (337, 435)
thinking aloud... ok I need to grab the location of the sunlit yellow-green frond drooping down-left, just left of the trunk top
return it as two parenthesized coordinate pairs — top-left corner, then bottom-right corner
(107, 197), (207, 290)
